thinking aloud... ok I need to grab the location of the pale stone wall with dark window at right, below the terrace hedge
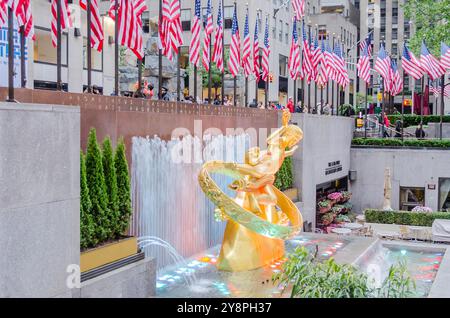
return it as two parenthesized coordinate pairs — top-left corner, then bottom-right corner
(350, 148), (450, 212)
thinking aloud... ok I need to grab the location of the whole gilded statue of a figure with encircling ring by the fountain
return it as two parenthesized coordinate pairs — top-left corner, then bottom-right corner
(198, 111), (303, 272)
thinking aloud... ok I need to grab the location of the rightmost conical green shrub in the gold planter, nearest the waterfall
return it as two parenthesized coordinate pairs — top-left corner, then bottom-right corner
(114, 138), (131, 235)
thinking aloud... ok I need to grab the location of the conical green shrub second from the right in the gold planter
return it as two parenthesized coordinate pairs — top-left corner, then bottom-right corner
(102, 137), (120, 239)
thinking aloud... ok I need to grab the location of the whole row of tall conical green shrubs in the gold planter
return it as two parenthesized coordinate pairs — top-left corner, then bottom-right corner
(80, 129), (131, 249)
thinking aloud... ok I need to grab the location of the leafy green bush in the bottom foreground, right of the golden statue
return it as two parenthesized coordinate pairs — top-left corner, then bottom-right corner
(272, 247), (415, 298)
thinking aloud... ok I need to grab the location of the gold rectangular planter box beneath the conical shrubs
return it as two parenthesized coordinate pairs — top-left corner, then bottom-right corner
(80, 237), (138, 273)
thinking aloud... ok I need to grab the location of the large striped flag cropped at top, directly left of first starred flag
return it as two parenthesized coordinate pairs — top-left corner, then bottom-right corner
(159, 0), (183, 61)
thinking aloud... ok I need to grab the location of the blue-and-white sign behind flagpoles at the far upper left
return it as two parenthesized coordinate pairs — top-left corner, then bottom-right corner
(0, 23), (28, 87)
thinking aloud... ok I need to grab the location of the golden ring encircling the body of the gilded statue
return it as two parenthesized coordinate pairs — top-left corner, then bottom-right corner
(198, 161), (303, 240)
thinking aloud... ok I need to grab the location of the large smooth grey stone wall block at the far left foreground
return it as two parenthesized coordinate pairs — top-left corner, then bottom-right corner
(0, 102), (80, 297)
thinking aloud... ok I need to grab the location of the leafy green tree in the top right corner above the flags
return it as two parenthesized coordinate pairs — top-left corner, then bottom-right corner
(403, 0), (450, 57)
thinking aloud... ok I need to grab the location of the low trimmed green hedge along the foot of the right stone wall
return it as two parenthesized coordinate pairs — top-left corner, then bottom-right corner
(364, 209), (450, 226)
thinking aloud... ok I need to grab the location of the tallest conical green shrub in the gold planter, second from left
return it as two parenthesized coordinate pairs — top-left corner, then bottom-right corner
(86, 128), (110, 242)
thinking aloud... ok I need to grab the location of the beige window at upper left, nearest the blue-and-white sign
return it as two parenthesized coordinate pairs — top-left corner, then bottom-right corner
(33, 27), (68, 66)
